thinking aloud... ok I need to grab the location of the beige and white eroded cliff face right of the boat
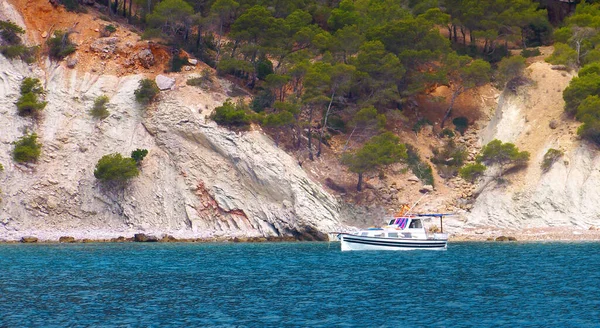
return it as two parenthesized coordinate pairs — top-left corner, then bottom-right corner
(463, 62), (600, 229)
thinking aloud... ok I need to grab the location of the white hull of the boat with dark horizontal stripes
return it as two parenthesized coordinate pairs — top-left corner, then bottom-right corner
(340, 234), (448, 251)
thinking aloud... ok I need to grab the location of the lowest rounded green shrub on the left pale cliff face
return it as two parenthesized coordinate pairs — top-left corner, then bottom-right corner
(94, 153), (140, 183)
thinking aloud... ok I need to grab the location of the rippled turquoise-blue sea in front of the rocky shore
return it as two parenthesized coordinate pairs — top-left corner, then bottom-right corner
(0, 243), (600, 327)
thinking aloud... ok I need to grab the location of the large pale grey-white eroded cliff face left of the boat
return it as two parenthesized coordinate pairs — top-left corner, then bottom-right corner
(0, 57), (340, 240)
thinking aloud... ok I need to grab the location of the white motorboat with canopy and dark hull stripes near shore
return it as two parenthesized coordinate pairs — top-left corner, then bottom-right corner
(339, 214), (449, 251)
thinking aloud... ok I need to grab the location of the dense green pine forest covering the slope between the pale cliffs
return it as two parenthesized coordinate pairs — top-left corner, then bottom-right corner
(50, 0), (552, 187)
